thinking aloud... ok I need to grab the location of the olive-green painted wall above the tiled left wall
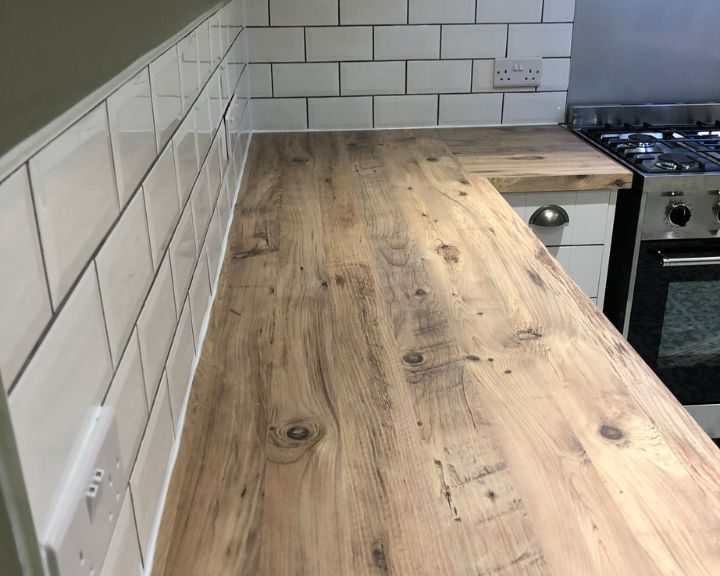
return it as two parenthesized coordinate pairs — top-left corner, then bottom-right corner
(0, 0), (220, 156)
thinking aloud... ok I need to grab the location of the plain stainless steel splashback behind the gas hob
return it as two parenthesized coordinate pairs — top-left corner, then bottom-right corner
(568, 0), (720, 104)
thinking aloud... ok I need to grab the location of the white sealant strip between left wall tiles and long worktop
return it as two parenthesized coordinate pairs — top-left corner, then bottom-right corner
(143, 132), (253, 576)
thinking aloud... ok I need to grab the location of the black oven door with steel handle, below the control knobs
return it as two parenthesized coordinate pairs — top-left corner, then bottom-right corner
(628, 239), (720, 438)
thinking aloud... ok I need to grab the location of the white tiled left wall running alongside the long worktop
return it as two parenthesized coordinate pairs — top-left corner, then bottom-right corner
(0, 0), (250, 576)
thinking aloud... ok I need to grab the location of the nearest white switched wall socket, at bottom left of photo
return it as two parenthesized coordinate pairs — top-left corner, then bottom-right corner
(43, 406), (127, 576)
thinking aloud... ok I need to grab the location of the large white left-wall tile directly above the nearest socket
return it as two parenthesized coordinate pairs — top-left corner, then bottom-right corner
(9, 266), (113, 534)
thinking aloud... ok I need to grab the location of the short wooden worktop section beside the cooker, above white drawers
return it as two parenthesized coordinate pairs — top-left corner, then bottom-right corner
(437, 126), (632, 192)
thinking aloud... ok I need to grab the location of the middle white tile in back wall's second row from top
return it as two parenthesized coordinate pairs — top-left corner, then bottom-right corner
(375, 26), (440, 60)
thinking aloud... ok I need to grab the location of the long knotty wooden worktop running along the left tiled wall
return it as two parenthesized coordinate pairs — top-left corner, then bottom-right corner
(153, 131), (720, 576)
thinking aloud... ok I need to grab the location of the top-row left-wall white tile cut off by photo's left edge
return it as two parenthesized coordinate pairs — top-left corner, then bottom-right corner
(0, 166), (52, 389)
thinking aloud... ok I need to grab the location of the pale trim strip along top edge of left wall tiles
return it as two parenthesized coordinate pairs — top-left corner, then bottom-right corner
(0, 0), (230, 181)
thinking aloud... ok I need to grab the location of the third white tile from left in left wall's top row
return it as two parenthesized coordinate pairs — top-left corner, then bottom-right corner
(107, 68), (157, 206)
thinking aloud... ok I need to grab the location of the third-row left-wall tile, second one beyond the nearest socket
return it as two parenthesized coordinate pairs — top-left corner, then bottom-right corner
(138, 255), (177, 406)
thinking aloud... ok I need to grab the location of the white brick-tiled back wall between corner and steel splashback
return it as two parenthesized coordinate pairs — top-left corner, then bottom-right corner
(247, 0), (575, 130)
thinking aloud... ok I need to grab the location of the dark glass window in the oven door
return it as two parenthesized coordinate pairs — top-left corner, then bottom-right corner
(657, 281), (720, 369)
